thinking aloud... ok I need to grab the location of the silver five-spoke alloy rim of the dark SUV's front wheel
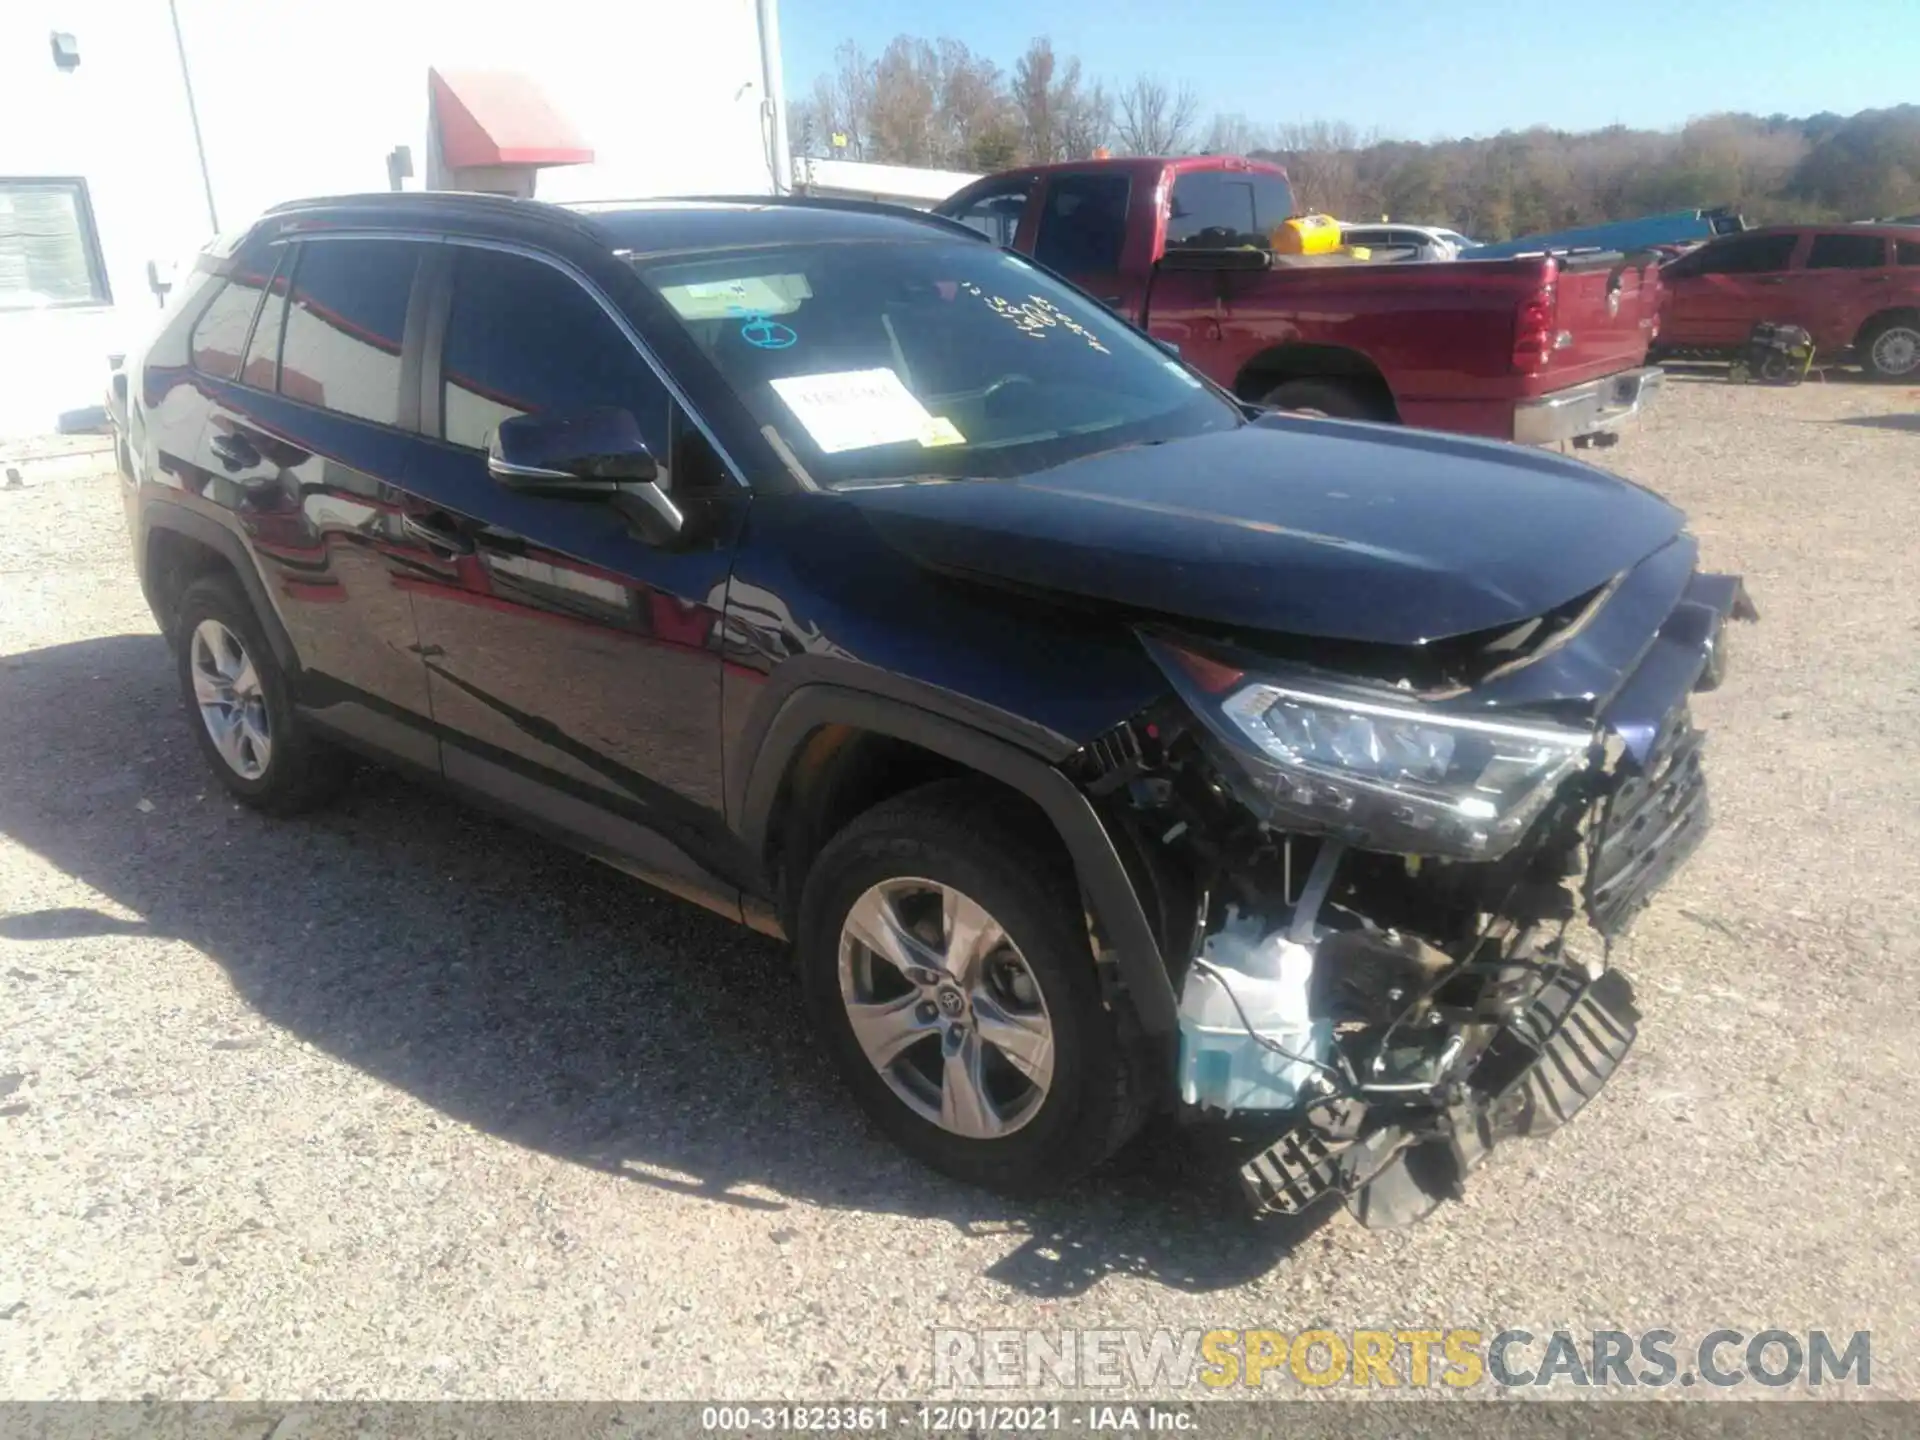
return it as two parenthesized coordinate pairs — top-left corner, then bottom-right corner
(839, 879), (1054, 1140)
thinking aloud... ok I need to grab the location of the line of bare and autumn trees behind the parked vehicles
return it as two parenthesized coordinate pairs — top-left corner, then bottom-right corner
(789, 35), (1920, 240)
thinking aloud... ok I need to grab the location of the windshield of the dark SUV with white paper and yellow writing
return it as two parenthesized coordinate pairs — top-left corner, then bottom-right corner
(632, 240), (1244, 486)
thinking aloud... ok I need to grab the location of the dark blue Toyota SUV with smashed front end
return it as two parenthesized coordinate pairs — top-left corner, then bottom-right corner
(123, 194), (1751, 1223)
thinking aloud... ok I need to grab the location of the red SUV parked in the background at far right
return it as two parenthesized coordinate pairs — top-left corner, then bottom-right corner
(1661, 225), (1920, 380)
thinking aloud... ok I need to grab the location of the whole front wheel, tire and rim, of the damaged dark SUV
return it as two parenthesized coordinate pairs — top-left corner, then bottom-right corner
(797, 781), (1144, 1194)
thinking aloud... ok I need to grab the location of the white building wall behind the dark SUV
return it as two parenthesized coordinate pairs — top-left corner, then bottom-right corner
(0, 0), (772, 434)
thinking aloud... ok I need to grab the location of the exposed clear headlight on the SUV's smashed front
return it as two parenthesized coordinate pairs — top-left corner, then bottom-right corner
(1146, 639), (1594, 860)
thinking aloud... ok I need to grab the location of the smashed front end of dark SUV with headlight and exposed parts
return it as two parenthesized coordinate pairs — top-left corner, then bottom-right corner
(1071, 534), (1757, 1225)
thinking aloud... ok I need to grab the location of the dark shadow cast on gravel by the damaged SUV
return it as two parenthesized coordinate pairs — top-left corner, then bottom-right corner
(0, 636), (1332, 1298)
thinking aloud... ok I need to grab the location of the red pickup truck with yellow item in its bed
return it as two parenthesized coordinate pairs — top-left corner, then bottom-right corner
(935, 156), (1661, 444)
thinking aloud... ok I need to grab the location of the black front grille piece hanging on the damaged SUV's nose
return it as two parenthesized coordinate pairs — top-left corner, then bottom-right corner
(1586, 710), (1711, 937)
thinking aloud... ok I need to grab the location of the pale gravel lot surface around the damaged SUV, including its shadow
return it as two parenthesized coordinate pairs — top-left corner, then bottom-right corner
(0, 376), (1920, 1398)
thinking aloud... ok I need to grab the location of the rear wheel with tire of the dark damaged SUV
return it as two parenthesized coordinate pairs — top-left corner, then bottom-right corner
(173, 576), (353, 816)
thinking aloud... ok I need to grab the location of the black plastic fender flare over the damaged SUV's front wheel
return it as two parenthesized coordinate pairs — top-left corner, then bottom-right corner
(733, 684), (1179, 1039)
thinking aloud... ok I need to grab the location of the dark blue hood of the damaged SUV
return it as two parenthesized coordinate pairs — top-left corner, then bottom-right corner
(847, 417), (1684, 645)
